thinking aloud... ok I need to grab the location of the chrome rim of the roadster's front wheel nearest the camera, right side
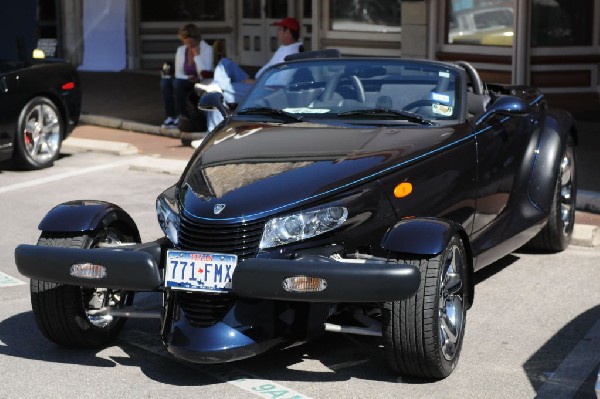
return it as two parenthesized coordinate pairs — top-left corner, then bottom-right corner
(438, 245), (466, 360)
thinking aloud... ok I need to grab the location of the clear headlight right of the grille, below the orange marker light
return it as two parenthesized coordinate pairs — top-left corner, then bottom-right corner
(260, 206), (348, 248)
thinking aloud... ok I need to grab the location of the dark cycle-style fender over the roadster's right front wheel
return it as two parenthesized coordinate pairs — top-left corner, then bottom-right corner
(381, 217), (475, 308)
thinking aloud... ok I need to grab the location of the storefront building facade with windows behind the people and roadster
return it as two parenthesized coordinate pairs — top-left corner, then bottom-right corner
(44, 0), (600, 98)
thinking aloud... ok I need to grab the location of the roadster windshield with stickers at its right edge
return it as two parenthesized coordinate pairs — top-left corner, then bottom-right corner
(236, 59), (464, 125)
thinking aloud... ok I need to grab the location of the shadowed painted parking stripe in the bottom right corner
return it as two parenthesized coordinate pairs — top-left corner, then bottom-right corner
(536, 320), (600, 399)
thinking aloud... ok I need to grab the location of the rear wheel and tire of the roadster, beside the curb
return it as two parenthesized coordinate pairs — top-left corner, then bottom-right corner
(526, 138), (577, 252)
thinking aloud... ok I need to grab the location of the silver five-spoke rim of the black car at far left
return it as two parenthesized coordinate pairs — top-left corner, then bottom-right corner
(22, 104), (61, 163)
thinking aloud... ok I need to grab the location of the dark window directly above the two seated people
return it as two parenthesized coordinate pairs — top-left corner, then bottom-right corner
(140, 0), (225, 22)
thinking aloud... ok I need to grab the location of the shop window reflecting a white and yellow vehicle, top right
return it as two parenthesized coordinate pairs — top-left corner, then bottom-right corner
(446, 0), (515, 46)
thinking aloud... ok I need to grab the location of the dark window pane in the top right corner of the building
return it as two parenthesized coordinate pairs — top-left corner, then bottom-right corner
(531, 0), (594, 47)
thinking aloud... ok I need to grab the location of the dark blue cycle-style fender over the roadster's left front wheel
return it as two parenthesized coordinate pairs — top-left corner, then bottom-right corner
(38, 201), (141, 242)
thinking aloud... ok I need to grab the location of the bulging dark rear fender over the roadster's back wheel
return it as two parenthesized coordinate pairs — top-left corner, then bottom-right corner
(528, 109), (577, 212)
